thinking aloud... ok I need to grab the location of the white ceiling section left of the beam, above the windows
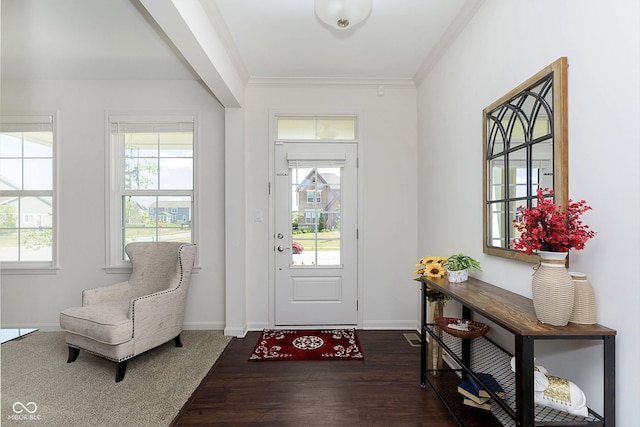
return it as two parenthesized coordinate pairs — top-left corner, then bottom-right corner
(0, 0), (194, 80)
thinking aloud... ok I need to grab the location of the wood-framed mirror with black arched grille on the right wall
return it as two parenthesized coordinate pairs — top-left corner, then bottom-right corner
(482, 57), (568, 262)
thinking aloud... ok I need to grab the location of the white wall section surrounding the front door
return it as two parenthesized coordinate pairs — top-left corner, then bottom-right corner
(245, 82), (417, 330)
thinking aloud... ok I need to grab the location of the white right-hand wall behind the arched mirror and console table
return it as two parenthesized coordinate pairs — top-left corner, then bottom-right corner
(418, 0), (640, 427)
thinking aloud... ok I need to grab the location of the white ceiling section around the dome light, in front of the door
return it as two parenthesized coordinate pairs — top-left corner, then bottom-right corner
(212, 0), (465, 78)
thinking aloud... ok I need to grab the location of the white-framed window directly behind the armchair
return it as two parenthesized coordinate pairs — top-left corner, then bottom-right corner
(107, 116), (195, 267)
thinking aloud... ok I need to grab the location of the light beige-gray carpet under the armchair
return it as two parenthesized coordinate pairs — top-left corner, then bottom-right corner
(0, 331), (231, 427)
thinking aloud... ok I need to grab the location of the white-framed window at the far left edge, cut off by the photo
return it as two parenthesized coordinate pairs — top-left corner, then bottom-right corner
(0, 115), (56, 268)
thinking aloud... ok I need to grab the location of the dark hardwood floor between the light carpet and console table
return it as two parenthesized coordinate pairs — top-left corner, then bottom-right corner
(172, 331), (457, 427)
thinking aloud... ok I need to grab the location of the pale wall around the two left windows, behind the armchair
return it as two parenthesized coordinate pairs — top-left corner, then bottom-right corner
(0, 80), (225, 329)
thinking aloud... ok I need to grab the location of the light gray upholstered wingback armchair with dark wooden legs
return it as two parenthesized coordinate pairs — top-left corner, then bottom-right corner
(60, 242), (196, 382)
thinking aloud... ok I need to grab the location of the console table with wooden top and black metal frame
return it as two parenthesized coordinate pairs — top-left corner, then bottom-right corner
(420, 277), (616, 427)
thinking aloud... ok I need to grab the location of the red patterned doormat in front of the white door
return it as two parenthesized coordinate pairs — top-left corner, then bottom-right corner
(249, 329), (364, 360)
